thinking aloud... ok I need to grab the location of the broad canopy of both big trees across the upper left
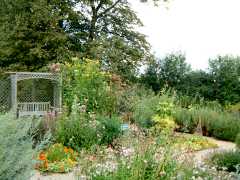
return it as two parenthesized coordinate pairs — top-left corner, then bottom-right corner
(0, 0), (149, 78)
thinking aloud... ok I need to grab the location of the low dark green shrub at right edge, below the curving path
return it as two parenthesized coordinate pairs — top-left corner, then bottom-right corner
(211, 150), (240, 172)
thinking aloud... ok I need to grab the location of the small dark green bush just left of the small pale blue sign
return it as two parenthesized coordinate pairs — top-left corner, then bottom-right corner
(97, 117), (121, 145)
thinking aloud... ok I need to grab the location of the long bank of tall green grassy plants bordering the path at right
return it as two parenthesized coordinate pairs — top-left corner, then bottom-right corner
(173, 107), (240, 141)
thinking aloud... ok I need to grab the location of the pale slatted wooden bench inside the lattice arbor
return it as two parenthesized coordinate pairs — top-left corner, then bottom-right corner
(17, 102), (51, 117)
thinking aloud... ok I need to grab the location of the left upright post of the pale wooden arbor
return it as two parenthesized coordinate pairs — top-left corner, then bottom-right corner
(11, 74), (17, 113)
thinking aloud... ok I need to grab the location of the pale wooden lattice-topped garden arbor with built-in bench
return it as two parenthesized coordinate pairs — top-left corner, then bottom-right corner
(8, 72), (62, 117)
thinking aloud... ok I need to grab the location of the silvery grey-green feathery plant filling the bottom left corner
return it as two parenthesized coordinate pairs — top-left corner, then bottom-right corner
(0, 113), (33, 180)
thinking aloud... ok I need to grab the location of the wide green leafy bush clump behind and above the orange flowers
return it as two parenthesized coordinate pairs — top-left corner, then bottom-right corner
(55, 99), (121, 151)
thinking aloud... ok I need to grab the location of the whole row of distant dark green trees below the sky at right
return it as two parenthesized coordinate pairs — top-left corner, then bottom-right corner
(141, 54), (240, 105)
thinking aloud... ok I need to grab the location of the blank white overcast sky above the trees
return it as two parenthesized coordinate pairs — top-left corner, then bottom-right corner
(130, 0), (240, 69)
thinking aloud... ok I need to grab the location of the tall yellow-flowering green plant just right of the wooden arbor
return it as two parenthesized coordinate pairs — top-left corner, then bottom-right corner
(62, 58), (116, 114)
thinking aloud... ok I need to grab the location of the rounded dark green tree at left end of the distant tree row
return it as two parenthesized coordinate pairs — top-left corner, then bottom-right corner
(142, 53), (191, 91)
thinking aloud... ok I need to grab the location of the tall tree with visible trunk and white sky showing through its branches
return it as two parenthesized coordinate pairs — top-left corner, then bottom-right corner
(66, 0), (149, 76)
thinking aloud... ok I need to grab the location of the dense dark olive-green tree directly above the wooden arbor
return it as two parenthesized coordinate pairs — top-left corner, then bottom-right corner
(0, 0), (76, 70)
